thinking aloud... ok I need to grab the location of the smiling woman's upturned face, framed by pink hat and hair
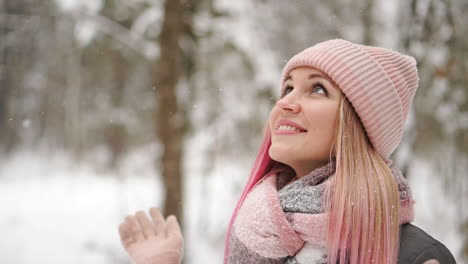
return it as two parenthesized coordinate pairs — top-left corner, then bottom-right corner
(269, 67), (341, 177)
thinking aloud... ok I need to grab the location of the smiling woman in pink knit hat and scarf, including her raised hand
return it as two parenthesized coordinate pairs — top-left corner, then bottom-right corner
(120, 39), (455, 264)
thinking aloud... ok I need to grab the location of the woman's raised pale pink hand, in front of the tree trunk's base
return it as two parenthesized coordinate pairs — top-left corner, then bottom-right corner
(119, 208), (183, 264)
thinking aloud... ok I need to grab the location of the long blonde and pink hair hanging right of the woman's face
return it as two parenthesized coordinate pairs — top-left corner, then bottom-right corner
(325, 95), (400, 264)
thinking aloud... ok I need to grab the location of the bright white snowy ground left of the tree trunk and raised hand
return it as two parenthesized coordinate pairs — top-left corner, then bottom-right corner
(0, 148), (160, 264)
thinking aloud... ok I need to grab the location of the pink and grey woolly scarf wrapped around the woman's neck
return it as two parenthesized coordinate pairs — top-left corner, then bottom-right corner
(228, 163), (414, 263)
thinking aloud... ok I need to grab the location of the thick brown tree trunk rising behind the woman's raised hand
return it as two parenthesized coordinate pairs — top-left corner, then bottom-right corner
(154, 0), (184, 222)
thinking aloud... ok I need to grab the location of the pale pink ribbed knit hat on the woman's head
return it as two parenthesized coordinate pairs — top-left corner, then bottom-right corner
(281, 39), (419, 159)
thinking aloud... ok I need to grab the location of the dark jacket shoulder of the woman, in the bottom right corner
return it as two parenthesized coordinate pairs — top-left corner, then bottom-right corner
(398, 224), (456, 264)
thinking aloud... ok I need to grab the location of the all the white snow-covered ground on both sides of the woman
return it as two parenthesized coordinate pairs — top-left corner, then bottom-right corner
(0, 145), (462, 264)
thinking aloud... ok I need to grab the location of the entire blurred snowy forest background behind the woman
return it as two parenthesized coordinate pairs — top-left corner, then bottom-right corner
(0, 0), (468, 264)
